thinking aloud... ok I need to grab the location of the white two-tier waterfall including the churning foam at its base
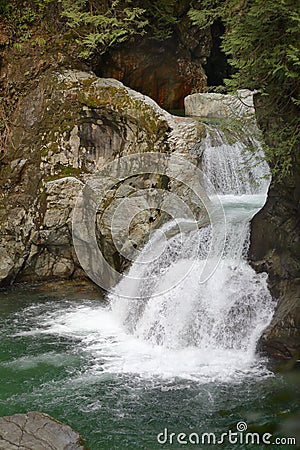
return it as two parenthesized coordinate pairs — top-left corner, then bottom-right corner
(36, 126), (274, 382)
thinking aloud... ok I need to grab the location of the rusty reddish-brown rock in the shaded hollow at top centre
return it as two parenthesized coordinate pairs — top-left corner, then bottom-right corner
(94, 35), (205, 111)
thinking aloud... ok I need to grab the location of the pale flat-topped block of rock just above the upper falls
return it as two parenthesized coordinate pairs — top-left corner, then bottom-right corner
(184, 89), (255, 119)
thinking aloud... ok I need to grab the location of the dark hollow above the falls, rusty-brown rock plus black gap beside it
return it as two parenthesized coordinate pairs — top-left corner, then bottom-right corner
(94, 21), (230, 115)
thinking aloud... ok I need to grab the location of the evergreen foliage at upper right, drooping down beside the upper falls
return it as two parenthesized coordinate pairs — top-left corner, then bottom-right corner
(189, 0), (300, 180)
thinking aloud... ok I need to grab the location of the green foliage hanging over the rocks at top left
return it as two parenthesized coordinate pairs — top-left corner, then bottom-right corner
(0, 0), (148, 58)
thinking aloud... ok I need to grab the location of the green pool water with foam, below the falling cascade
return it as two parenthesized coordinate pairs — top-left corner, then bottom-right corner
(0, 285), (300, 450)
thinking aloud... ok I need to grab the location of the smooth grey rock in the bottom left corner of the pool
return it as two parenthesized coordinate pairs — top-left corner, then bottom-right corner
(0, 412), (88, 450)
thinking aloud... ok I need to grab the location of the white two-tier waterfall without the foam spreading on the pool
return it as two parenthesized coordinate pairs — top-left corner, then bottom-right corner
(109, 127), (274, 360)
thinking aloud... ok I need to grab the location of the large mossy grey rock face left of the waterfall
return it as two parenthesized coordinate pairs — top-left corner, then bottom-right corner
(0, 71), (204, 285)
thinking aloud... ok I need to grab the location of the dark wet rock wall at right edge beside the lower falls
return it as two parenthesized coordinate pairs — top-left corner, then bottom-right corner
(249, 192), (300, 357)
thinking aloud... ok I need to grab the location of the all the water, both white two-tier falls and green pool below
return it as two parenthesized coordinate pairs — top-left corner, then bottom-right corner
(0, 125), (300, 450)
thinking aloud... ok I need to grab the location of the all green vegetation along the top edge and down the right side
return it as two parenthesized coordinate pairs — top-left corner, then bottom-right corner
(0, 0), (300, 181)
